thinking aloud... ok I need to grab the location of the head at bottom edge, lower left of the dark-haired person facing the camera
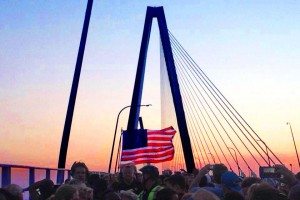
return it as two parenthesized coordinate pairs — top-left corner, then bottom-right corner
(54, 185), (79, 200)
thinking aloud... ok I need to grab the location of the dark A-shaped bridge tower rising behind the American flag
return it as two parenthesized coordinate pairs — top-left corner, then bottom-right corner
(127, 7), (195, 173)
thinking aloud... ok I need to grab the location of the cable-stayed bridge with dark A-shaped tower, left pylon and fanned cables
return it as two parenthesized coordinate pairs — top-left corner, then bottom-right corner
(1, 1), (298, 192)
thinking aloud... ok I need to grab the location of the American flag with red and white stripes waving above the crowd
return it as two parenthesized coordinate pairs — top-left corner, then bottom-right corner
(121, 127), (176, 164)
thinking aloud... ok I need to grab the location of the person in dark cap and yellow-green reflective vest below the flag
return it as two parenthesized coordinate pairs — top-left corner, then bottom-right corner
(138, 165), (163, 200)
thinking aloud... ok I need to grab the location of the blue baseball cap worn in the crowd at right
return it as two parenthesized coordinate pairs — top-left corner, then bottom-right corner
(221, 171), (242, 192)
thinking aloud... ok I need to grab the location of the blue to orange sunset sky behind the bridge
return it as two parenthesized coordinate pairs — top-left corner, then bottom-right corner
(0, 0), (300, 171)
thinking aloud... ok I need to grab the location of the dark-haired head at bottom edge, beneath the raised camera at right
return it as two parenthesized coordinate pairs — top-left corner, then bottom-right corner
(246, 183), (288, 200)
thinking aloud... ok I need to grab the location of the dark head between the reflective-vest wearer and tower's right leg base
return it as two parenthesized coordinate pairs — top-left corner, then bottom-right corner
(165, 174), (186, 194)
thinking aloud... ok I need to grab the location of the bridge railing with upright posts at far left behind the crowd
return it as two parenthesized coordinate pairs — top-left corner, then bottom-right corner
(0, 164), (70, 190)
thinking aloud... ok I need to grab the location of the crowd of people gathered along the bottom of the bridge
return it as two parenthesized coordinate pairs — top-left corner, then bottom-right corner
(0, 162), (300, 200)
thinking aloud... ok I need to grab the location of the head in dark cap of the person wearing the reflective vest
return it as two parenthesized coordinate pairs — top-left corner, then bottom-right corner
(140, 165), (159, 190)
